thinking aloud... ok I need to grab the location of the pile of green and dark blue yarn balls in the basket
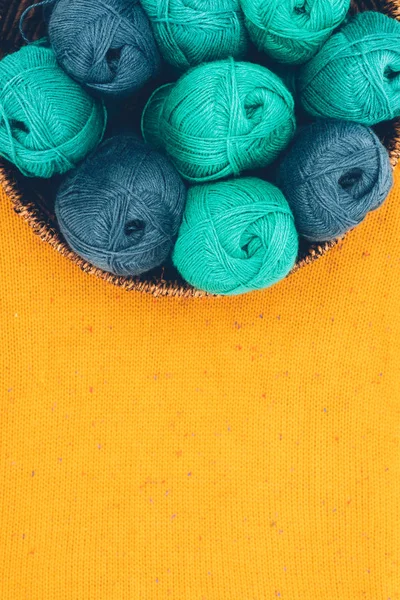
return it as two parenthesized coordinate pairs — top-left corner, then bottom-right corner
(0, 0), (394, 295)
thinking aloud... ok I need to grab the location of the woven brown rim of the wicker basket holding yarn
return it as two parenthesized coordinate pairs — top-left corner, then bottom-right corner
(0, 0), (400, 298)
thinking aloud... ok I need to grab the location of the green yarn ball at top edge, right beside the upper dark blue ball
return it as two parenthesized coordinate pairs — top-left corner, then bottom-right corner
(142, 0), (247, 70)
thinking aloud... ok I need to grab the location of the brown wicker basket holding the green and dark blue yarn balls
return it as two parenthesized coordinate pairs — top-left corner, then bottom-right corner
(0, 0), (400, 297)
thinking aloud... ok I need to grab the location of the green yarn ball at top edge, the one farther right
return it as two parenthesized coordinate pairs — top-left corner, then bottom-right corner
(241, 0), (350, 64)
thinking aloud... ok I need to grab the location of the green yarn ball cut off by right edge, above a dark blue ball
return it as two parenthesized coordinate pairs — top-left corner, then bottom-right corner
(299, 12), (400, 125)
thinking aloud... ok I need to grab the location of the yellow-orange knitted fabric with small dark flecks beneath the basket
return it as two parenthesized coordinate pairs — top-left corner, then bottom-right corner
(0, 171), (400, 600)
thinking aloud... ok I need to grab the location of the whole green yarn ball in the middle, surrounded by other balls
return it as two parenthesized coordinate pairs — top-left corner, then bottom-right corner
(142, 59), (295, 182)
